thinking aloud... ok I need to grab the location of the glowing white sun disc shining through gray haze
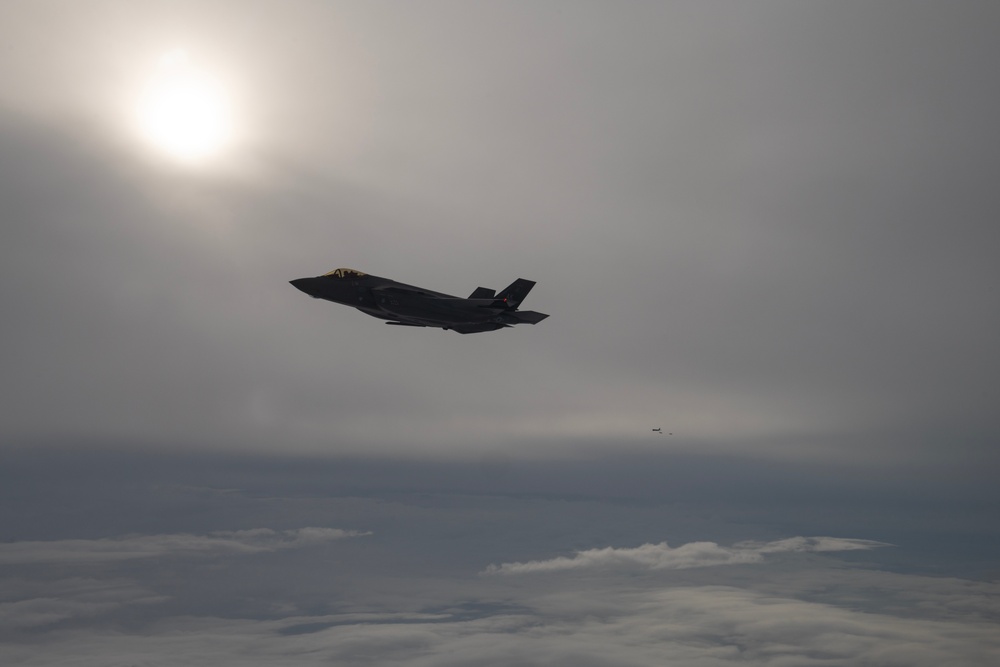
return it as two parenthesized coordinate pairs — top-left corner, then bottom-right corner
(138, 49), (232, 161)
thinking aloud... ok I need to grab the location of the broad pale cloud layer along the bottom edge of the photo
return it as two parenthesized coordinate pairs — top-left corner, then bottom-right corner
(0, 571), (1000, 667)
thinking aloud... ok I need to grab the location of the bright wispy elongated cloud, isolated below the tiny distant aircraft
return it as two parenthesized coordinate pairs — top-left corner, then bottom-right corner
(483, 537), (892, 574)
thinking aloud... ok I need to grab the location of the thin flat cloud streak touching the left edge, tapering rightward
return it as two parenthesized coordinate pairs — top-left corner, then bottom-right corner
(0, 527), (371, 565)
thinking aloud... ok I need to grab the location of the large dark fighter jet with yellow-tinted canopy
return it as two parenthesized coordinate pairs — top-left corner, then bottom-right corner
(291, 269), (548, 333)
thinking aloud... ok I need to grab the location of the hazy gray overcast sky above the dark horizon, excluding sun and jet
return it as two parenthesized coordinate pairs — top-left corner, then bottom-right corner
(0, 3), (1000, 468)
